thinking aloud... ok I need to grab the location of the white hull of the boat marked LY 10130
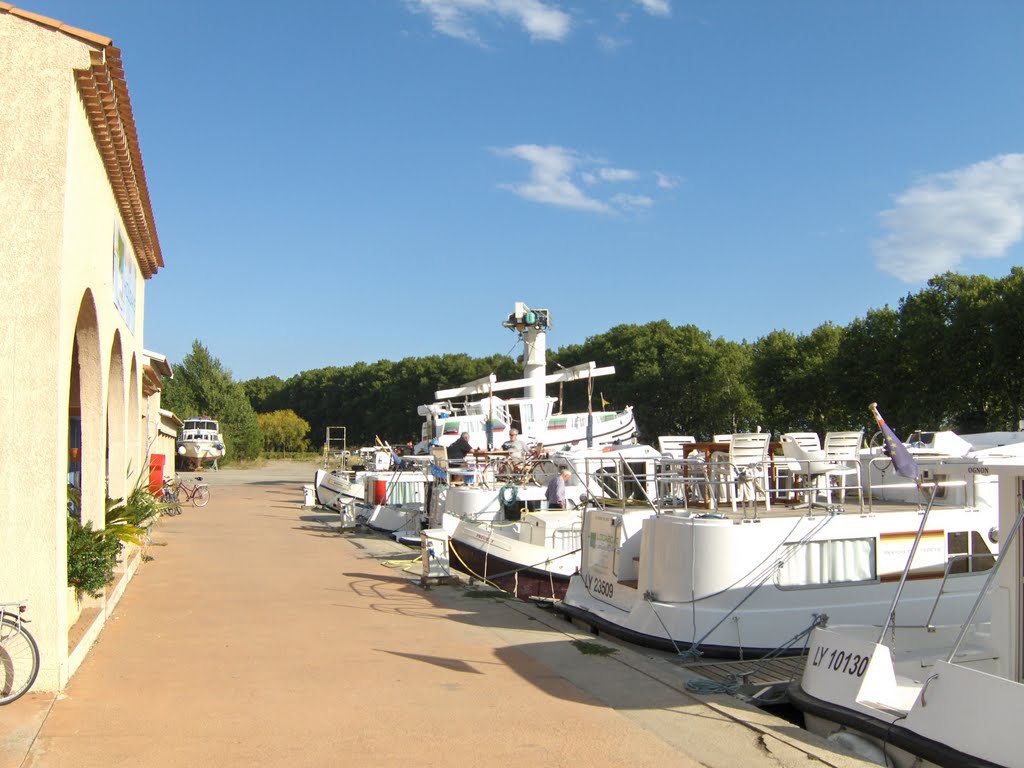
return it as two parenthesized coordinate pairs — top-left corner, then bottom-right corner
(788, 627), (1007, 768)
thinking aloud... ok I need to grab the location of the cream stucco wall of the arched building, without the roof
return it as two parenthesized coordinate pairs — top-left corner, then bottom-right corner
(0, 13), (153, 690)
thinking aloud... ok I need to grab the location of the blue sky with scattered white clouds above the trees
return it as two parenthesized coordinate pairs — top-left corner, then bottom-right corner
(15, 0), (1024, 380)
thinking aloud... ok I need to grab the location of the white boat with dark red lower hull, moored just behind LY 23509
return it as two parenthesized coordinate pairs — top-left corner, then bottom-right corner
(440, 445), (660, 599)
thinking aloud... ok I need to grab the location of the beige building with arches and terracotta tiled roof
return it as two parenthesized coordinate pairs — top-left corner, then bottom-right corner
(0, 2), (172, 690)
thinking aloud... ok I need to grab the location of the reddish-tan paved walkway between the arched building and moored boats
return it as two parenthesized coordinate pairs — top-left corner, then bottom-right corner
(0, 463), (864, 768)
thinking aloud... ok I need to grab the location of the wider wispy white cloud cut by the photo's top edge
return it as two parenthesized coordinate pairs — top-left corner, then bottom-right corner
(407, 0), (571, 43)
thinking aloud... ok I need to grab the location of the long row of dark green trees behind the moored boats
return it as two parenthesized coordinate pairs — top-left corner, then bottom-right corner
(165, 267), (1024, 460)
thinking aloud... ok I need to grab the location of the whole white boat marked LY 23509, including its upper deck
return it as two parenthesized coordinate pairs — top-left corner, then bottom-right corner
(557, 434), (997, 657)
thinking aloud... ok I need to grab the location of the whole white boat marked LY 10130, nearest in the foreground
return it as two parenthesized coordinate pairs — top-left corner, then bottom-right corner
(790, 433), (1024, 768)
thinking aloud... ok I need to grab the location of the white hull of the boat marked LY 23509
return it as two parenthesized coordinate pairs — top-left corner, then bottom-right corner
(559, 510), (990, 657)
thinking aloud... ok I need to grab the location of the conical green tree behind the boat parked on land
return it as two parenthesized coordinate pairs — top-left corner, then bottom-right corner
(161, 339), (263, 461)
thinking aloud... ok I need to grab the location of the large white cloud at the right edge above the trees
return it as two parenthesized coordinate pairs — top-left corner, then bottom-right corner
(873, 154), (1024, 283)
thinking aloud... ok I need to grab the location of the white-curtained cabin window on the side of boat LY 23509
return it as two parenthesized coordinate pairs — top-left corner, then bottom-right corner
(775, 537), (877, 587)
